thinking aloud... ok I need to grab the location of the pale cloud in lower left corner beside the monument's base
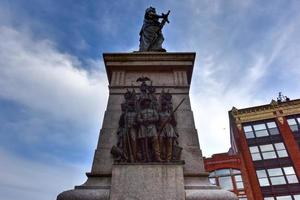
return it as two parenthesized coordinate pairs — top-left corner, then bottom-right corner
(0, 149), (88, 200)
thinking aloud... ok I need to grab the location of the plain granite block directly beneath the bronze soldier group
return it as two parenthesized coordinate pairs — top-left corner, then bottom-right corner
(110, 164), (185, 200)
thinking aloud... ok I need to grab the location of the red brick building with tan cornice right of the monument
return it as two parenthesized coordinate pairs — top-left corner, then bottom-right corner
(205, 98), (300, 200)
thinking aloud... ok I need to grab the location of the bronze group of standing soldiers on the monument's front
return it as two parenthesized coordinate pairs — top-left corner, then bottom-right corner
(111, 77), (184, 162)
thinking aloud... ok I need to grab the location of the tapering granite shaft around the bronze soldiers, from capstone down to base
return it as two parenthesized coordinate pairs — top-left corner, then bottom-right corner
(91, 53), (204, 175)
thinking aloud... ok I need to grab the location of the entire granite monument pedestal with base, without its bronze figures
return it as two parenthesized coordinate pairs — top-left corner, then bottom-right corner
(57, 52), (237, 200)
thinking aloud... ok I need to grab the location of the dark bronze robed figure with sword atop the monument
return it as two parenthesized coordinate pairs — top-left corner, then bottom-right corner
(139, 7), (170, 52)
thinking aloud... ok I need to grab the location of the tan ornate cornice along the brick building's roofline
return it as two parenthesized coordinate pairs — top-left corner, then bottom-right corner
(229, 99), (300, 124)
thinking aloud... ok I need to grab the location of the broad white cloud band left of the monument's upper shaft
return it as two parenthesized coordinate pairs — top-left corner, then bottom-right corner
(0, 26), (108, 126)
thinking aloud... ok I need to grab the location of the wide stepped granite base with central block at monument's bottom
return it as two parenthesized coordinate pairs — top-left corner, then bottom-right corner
(57, 162), (237, 200)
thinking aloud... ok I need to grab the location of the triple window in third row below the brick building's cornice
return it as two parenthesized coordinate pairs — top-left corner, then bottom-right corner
(256, 166), (298, 187)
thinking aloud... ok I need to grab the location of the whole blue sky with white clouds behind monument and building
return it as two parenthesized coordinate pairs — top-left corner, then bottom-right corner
(0, 0), (300, 200)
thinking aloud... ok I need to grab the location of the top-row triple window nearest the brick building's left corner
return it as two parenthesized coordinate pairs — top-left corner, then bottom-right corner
(243, 121), (279, 139)
